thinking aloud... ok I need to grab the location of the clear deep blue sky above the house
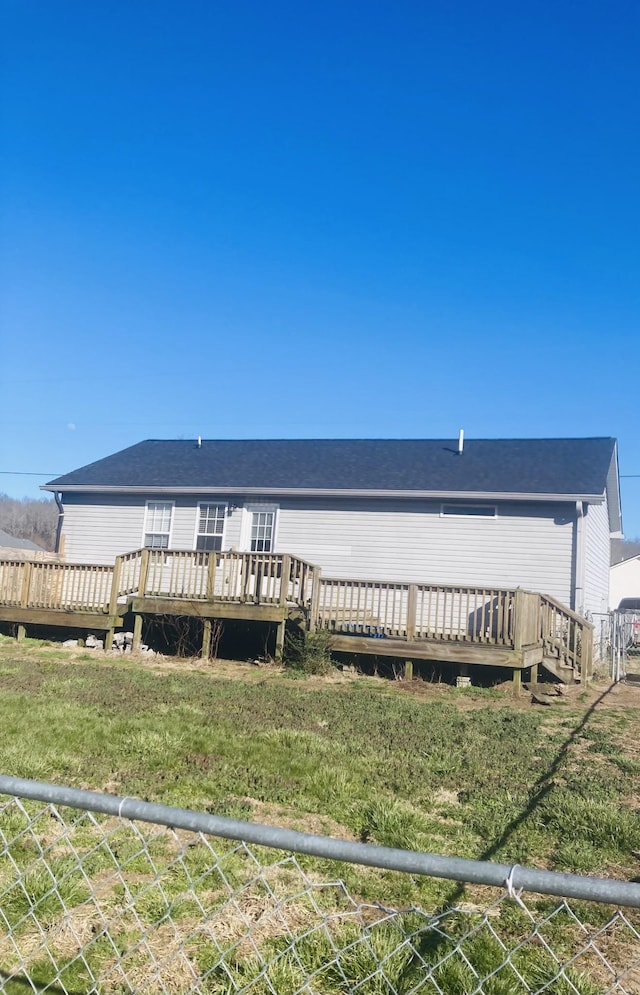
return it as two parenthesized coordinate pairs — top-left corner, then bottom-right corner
(0, 0), (640, 537)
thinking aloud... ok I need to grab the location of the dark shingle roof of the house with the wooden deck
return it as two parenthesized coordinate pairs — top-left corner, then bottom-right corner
(46, 438), (615, 496)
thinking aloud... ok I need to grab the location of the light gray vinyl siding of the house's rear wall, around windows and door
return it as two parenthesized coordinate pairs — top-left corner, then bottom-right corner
(63, 495), (575, 604)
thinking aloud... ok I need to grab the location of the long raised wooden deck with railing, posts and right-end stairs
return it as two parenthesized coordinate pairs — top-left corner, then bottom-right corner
(0, 549), (592, 680)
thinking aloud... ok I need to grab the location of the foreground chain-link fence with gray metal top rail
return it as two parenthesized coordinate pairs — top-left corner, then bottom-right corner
(0, 776), (640, 995)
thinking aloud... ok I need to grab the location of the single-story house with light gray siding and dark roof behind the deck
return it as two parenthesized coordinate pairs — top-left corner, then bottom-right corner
(44, 438), (621, 613)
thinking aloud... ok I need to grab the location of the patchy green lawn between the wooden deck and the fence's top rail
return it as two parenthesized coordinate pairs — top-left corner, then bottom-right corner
(0, 637), (640, 993)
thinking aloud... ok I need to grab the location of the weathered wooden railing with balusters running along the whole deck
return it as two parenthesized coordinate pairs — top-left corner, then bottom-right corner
(0, 549), (593, 676)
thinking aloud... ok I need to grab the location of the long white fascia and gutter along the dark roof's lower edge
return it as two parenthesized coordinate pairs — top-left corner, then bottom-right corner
(40, 484), (604, 504)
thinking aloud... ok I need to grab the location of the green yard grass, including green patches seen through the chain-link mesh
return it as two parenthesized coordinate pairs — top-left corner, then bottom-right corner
(0, 639), (640, 995)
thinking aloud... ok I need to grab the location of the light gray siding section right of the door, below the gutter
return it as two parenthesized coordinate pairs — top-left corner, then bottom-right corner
(276, 501), (575, 604)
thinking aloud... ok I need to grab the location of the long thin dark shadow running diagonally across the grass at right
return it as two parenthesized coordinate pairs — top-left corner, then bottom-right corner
(401, 684), (615, 980)
